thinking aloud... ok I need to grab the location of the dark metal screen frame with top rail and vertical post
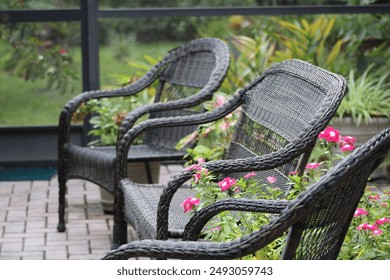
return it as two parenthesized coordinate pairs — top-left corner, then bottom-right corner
(0, 0), (390, 165)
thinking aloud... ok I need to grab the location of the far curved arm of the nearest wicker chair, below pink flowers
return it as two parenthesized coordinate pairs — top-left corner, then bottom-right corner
(183, 198), (290, 241)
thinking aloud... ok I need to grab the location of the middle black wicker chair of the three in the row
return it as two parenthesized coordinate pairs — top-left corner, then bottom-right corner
(114, 60), (345, 245)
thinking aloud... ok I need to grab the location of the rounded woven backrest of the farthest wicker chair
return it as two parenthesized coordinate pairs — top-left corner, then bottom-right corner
(144, 38), (230, 149)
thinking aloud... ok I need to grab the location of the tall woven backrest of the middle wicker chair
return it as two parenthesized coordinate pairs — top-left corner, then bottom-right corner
(226, 60), (346, 188)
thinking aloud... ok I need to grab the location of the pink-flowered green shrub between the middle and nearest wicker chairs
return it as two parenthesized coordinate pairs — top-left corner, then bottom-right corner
(182, 127), (390, 259)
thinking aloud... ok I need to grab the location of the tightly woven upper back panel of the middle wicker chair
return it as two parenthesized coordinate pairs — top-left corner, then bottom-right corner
(243, 72), (327, 142)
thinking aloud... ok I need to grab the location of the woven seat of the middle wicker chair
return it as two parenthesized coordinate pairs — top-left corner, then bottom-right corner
(120, 179), (194, 239)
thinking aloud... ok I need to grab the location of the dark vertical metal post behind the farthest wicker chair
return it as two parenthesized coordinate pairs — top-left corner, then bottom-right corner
(80, 0), (100, 145)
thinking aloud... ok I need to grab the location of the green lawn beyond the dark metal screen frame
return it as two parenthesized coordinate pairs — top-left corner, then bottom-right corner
(0, 43), (179, 126)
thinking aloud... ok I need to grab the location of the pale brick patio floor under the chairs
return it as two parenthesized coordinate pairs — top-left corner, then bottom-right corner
(0, 165), (182, 260)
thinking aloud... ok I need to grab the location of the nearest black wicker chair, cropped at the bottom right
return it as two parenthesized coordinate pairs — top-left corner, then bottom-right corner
(104, 128), (390, 260)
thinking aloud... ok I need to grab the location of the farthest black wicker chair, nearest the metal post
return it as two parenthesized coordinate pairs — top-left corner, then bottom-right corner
(57, 38), (230, 232)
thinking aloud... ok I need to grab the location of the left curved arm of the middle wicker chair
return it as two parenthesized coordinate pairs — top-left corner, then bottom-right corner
(116, 94), (242, 179)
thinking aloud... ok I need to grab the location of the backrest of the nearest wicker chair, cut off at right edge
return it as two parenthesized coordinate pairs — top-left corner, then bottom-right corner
(280, 128), (390, 259)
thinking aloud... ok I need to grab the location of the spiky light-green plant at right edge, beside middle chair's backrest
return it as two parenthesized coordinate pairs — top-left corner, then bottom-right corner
(337, 65), (390, 125)
